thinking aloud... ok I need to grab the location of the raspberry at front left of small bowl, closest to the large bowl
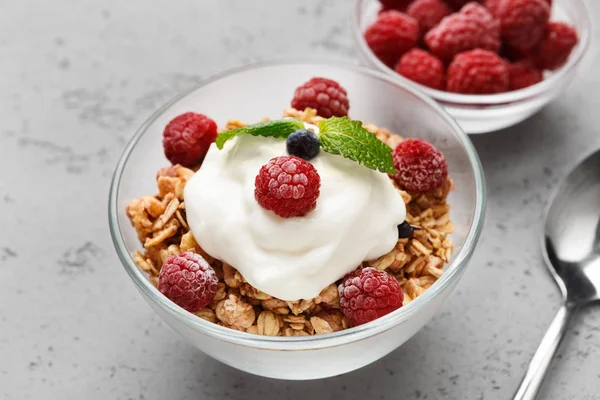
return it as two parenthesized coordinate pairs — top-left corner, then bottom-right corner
(395, 49), (446, 90)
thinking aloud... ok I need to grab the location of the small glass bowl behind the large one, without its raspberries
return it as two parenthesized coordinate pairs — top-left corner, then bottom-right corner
(352, 0), (591, 134)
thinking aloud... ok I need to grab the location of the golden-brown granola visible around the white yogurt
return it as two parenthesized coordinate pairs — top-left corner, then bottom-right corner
(127, 109), (454, 336)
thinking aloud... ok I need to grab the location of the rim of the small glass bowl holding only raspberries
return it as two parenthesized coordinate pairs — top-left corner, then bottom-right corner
(351, 0), (592, 106)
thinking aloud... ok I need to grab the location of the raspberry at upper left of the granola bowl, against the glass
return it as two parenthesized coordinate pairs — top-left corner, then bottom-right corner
(163, 112), (217, 167)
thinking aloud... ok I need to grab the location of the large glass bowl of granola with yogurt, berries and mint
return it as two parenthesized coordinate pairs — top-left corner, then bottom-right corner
(110, 63), (484, 379)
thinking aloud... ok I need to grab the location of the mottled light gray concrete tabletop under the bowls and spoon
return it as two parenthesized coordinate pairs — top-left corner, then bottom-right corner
(0, 0), (600, 400)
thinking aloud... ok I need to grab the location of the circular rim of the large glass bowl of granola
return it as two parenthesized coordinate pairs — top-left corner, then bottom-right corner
(108, 58), (486, 351)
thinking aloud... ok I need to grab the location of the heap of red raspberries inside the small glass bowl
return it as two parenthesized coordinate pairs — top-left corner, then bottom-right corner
(365, 0), (578, 94)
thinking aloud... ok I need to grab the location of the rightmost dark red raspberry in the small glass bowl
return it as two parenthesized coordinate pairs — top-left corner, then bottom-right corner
(534, 22), (579, 70)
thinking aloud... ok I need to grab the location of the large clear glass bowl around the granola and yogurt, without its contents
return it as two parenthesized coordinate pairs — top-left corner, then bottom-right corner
(109, 61), (485, 380)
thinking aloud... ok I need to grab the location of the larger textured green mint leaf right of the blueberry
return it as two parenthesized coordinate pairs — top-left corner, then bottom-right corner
(319, 117), (396, 174)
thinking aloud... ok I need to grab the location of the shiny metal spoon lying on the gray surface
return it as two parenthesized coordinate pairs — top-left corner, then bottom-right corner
(514, 150), (600, 400)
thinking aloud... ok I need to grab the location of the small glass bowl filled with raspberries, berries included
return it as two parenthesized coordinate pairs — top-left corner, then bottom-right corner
(353, 0), (590, 134)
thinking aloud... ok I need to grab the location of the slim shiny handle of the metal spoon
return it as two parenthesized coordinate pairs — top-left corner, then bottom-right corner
(514, 302), (577, 400)
